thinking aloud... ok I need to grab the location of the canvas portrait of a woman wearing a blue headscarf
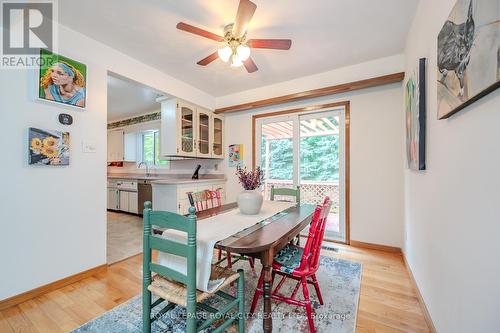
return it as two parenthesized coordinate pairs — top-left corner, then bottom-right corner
(38, 49), (87, 109)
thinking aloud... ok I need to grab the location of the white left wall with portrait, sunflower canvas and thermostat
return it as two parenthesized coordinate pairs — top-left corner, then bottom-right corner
(0, 26), (215, 299)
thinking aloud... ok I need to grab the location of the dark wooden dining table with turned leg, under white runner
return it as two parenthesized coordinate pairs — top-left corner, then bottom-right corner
(191, 203), (316, 333)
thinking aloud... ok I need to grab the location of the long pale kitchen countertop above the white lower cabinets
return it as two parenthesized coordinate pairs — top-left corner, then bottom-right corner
(108, 173), (226, 185)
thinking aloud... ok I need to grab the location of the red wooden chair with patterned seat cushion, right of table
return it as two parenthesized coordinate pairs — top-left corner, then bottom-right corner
(250, 197), (332, 333)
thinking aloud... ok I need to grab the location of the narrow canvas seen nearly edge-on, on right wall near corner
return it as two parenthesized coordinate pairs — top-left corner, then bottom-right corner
(405, 58), (426, 170)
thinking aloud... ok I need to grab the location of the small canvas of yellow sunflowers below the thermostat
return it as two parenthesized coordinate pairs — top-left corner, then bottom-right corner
(28, 127), (69, 165)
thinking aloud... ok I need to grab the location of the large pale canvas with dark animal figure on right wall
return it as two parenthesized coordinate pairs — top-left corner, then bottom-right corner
(437, 0), (500, 119)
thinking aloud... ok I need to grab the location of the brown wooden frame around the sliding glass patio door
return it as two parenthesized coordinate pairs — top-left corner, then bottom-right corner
(252, 101), (351, 245)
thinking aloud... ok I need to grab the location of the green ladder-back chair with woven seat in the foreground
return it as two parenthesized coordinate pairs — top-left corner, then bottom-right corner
(142, 201), (245, 333)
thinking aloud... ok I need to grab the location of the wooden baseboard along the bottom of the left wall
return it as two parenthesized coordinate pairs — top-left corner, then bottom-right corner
(0, 264), (108, 310)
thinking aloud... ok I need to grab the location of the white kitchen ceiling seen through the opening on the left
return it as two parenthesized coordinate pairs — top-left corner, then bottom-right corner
(108, 75), (160, 121)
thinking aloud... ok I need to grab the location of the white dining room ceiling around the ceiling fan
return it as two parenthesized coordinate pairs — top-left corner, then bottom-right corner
(59, 0), (418, 97)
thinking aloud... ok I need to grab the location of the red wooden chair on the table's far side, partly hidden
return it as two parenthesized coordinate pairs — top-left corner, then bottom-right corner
(188, 188), (257, 276)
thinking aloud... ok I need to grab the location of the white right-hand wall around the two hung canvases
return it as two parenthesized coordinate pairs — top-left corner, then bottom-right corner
(404, 0), (500, 333)
